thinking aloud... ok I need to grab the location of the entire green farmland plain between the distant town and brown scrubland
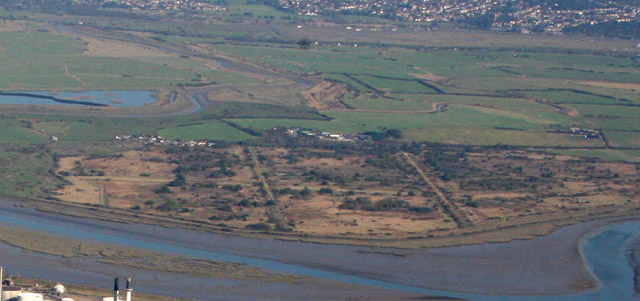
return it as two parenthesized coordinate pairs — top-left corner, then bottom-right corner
(0, 12), (640, 176)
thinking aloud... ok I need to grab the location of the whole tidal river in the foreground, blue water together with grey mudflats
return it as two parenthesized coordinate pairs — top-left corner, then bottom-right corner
(0, 202), (640, 299)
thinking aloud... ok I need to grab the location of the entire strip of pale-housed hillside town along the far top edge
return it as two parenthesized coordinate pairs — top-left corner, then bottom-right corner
(11, 0), (640, 37)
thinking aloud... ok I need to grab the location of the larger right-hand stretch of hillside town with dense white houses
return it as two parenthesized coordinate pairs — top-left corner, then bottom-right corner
(277, 0), (640, 33)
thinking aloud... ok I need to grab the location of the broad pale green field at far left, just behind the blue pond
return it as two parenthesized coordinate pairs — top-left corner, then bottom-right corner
(0, 27), (253, 91)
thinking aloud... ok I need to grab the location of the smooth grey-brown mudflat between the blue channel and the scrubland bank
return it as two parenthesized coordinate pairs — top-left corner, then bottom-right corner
(3, 199), (632, 298)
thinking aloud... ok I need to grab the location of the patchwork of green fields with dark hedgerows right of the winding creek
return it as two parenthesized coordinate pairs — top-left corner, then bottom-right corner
(199, 37), (640, 155)
